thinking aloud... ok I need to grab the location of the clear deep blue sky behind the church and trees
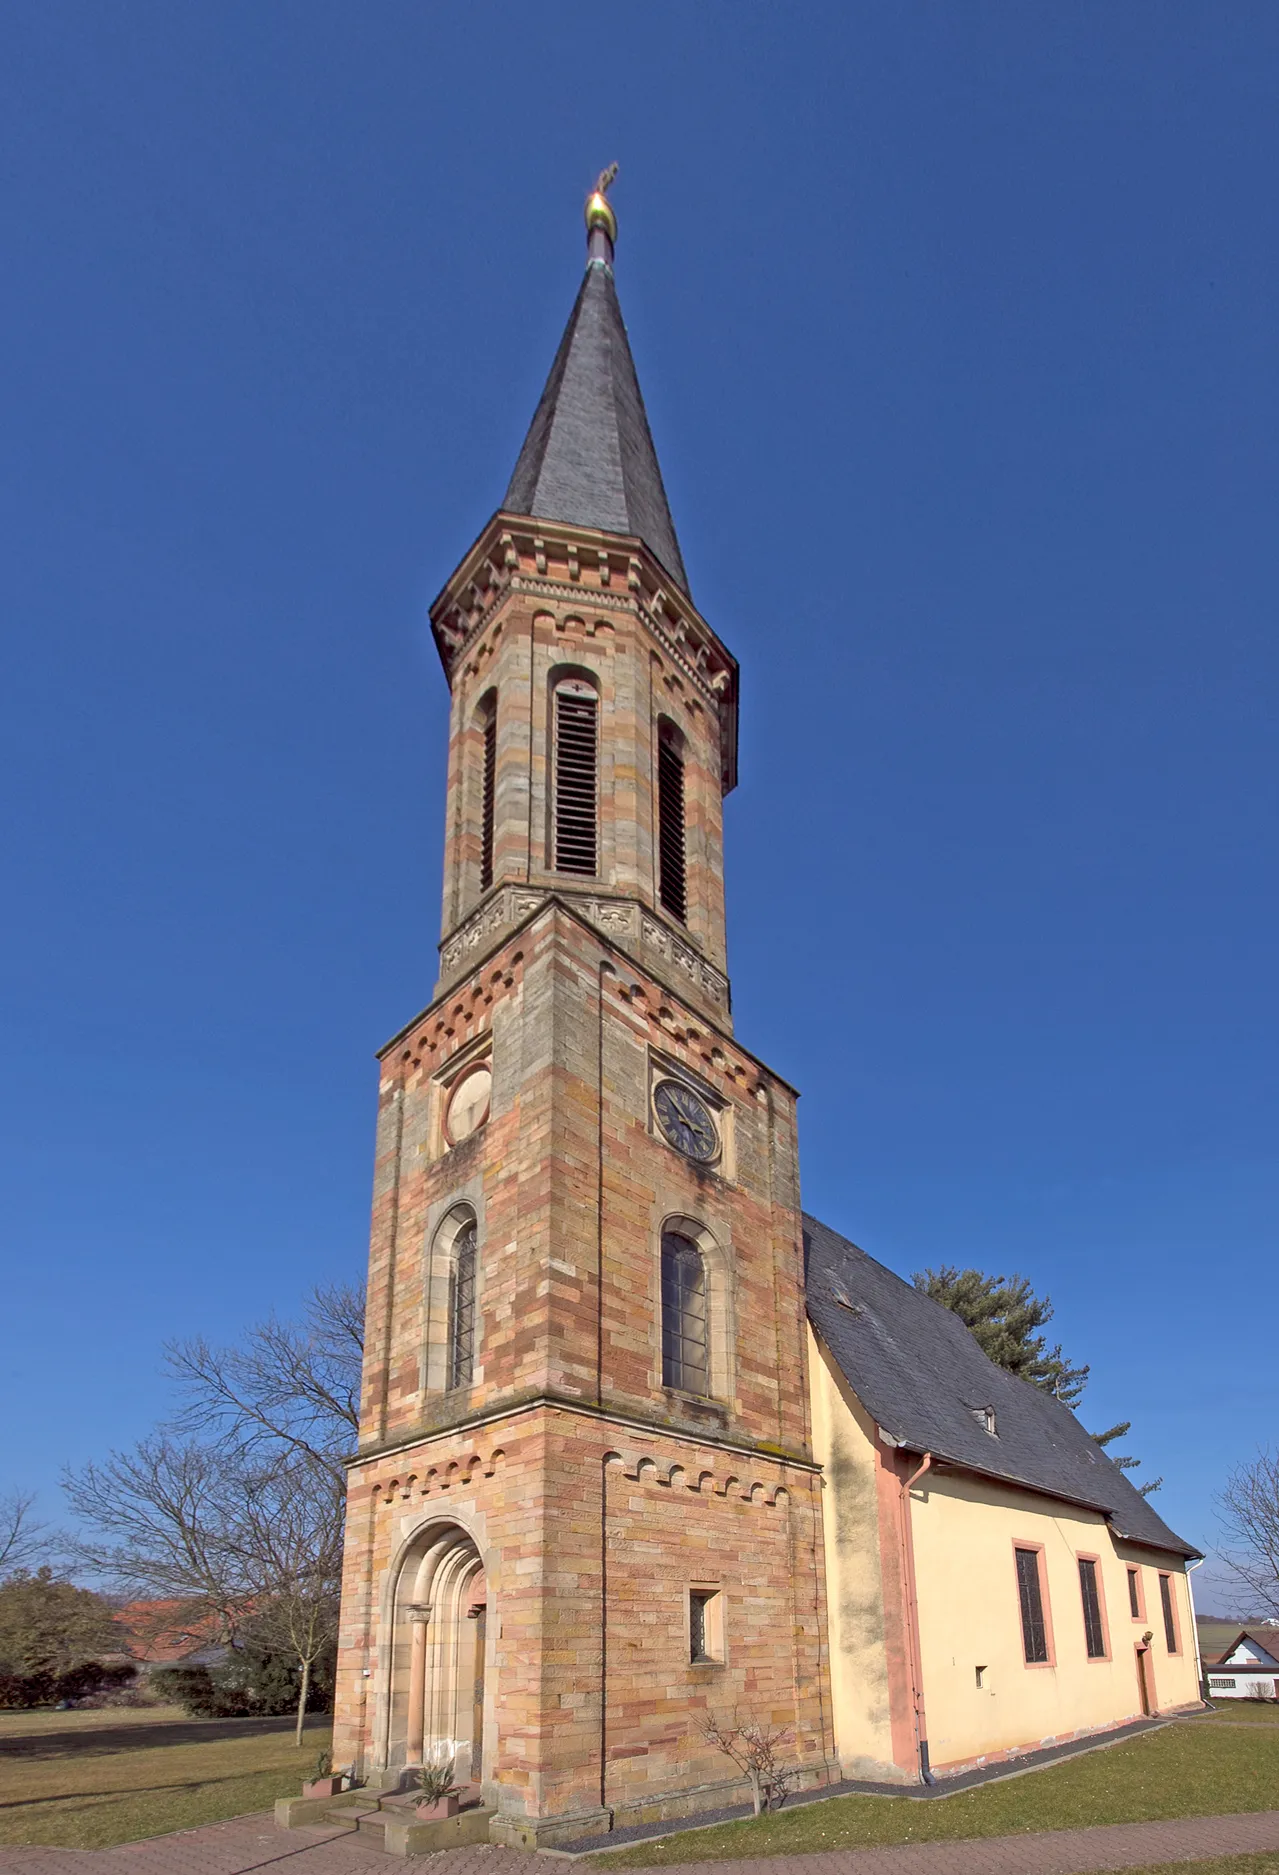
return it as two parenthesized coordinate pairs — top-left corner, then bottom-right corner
(0, 0), (1279, 1605)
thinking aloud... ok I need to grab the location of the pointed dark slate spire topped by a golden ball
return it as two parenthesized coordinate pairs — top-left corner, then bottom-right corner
(503, 163), (688, 593)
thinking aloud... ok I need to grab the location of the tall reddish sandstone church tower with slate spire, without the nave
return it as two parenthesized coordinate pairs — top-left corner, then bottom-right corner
(334, 178), (825, 1847)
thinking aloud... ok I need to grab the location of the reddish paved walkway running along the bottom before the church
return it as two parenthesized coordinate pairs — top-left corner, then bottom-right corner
(0, 1809), (1279, 1875)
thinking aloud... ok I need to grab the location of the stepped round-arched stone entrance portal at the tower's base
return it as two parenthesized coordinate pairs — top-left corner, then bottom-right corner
(386, 1524), (488, 1783)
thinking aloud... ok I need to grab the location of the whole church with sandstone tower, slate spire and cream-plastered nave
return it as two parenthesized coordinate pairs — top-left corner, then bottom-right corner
(334, 178), (1198, 1847)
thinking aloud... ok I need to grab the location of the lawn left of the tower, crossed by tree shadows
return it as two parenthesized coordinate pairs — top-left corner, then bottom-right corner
(0, 1706), (328, 1849)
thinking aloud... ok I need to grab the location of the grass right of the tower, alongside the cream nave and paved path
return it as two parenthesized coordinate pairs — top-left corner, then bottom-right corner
(592, 1719), (1279, 1871)
